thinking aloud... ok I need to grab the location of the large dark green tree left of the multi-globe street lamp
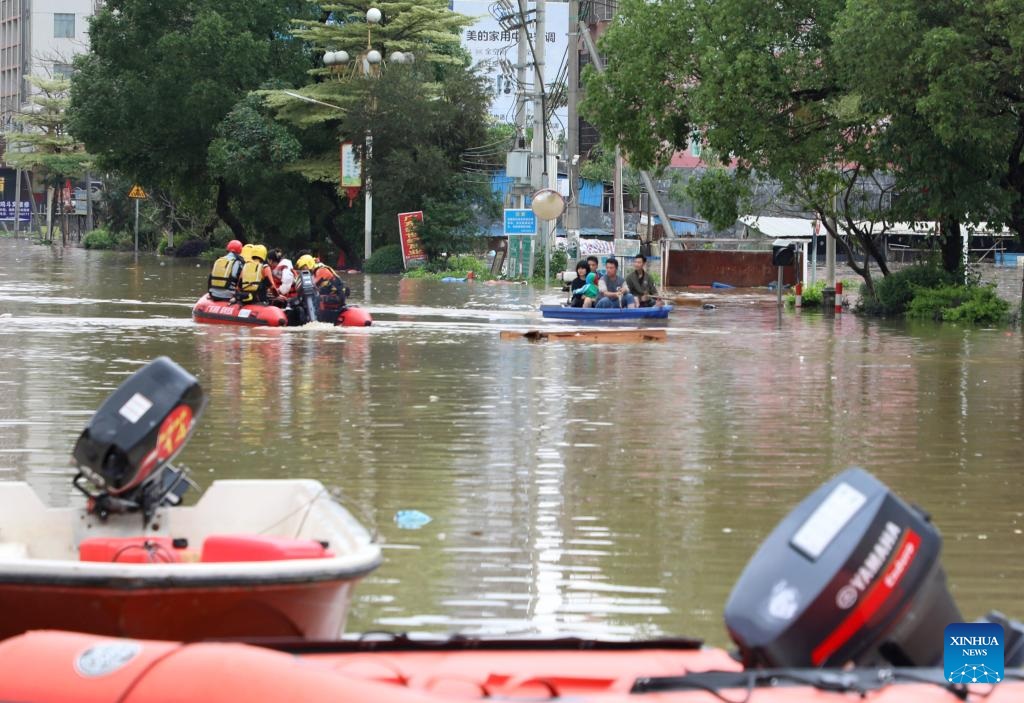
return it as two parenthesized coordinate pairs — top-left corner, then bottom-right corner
(69, 0), (309, 236)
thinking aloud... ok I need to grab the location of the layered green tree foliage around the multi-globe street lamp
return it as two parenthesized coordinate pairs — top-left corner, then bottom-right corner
(264, 0), (496, 256)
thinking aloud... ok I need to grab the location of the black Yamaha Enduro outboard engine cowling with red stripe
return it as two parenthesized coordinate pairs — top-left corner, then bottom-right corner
(725, 469), (962, 667)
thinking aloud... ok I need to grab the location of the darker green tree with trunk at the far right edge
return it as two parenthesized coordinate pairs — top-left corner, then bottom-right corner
(834, 0), (1024, 271)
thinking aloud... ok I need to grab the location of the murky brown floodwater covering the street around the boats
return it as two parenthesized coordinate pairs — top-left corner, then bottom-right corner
(0, 239), (1024, 644)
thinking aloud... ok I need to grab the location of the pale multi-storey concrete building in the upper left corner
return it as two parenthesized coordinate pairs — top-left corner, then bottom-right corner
(0, 0), (98, 125)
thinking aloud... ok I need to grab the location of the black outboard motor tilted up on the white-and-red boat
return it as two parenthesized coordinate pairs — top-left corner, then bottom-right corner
(74, 356), (206, 524)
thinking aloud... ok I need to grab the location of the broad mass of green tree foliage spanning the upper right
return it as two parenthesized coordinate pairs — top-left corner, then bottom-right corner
(584, 0), (1024, 293)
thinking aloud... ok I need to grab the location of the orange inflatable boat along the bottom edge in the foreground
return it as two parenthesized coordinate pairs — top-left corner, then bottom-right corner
(0, 631), (1024, 703)
